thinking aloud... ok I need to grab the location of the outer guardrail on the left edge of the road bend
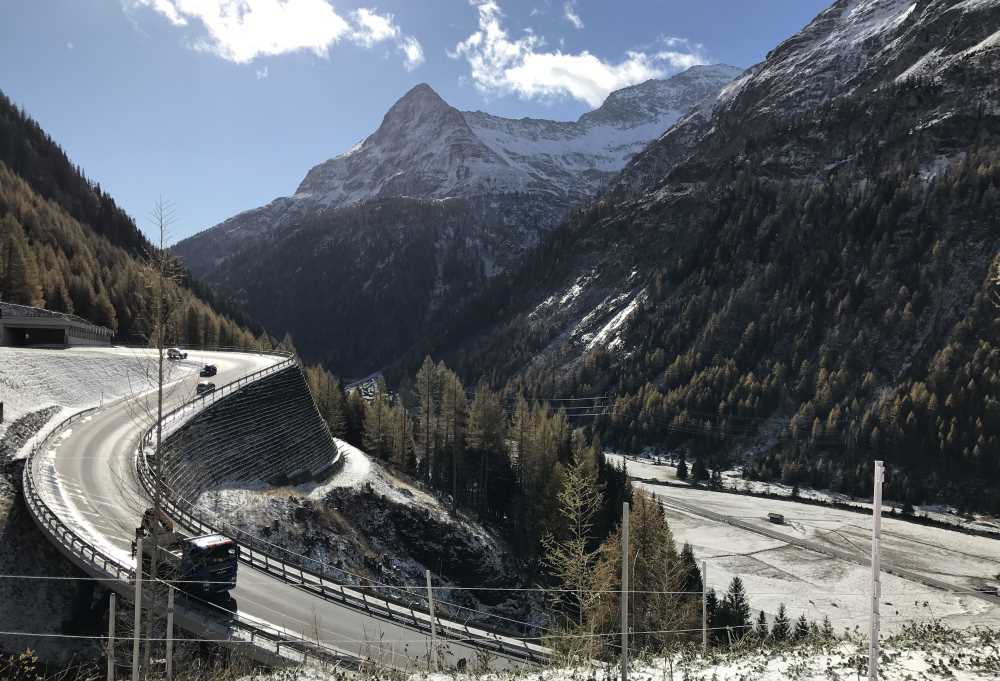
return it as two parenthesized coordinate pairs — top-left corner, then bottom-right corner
(22, 408), (357, 666)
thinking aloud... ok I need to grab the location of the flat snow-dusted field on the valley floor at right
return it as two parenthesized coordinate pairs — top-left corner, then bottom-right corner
(636, 472), (1000, 632)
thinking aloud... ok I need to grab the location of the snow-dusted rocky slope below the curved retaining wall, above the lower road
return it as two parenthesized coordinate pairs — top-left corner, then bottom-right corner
(197, 440), (541, 630)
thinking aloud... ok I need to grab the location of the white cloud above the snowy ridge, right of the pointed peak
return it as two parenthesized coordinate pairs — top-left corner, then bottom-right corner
(449, 0), (705, 107)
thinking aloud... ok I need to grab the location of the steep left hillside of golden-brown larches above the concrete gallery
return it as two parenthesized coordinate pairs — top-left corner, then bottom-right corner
(0, 93), (256, 345)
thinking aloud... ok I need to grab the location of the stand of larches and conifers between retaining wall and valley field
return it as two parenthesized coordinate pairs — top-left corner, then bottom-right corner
(306, 357), (834, 657)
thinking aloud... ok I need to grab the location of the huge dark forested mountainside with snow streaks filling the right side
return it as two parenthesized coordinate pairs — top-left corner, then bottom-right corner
(428, 0), (1000, 511)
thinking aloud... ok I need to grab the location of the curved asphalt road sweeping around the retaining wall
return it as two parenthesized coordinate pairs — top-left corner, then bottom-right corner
(33, 351), (540, 669)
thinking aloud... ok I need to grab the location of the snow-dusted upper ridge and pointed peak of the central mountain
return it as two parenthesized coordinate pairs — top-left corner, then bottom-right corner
(175, 65), (740, 277)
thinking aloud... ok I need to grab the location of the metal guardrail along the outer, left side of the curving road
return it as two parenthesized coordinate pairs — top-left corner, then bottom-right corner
(22, 358), (356, 665)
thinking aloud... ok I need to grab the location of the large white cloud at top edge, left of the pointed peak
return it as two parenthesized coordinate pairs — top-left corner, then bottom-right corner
(125, 0), (423, 69)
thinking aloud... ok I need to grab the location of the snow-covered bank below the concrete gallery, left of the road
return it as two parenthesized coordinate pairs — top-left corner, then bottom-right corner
(0, 347), (201, 456)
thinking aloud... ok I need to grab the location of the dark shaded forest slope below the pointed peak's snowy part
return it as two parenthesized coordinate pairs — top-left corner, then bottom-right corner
(195, 198), (556, 376)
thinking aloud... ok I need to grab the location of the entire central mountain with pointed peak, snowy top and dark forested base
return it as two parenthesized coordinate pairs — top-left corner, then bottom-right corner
(174, 65), (740, 376)
